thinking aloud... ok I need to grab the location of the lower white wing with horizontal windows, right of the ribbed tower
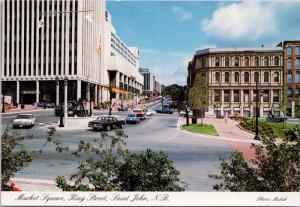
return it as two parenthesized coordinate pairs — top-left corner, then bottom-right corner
(102, 11), (143, 104)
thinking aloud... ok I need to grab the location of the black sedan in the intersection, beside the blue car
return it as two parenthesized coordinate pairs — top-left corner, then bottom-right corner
(88, 116), (124, 131)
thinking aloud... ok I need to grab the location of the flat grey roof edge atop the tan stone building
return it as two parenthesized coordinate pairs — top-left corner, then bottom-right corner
(196, 47), (282, 55)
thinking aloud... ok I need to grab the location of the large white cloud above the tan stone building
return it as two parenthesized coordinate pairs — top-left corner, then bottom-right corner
(201, 0), (276, 40)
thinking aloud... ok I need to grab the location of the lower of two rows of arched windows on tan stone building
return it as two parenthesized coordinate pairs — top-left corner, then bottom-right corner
(215, 71), (279, 83)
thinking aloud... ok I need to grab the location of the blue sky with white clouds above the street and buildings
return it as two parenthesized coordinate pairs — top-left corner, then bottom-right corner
(107, 0), (300, 85)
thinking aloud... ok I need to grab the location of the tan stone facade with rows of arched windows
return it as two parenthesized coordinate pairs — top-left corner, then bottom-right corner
(187, 47), (284, 117)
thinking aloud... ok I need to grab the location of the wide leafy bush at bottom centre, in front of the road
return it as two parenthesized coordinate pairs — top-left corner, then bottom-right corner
(56, 130), (184, 191)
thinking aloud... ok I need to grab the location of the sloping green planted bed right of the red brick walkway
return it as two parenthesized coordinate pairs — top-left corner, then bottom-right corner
(240, 118), (298, 139)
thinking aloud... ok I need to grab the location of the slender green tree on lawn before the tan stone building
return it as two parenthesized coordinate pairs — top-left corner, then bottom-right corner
(189, 74), (211, 126)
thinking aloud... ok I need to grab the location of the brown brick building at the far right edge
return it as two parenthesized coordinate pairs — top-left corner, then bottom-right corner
(277, 40), (300, 117)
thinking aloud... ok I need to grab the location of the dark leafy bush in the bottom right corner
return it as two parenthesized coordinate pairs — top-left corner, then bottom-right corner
(209, 132), (300, 192)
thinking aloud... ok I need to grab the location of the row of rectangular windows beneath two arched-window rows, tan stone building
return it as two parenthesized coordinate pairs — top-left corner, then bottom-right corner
(214, 90), (280, 103)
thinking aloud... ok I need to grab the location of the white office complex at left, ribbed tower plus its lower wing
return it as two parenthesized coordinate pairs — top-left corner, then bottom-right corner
(0, 0), (143, 105)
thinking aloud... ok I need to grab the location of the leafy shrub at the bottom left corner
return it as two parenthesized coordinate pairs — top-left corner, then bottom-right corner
(1, 127), (68, 191)
